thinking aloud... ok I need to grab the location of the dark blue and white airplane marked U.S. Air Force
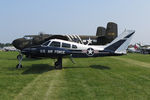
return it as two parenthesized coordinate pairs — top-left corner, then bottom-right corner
(16, 30), (135, 69)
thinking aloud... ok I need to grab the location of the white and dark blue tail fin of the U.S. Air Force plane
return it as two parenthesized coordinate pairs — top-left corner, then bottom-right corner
(104, 30), (135, 54)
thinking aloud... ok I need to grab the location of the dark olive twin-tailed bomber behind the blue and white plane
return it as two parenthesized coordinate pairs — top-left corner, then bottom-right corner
(12, 22), (118, 50)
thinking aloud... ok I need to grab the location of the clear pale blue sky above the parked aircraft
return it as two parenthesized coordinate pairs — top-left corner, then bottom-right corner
(0, 0), (150, 44)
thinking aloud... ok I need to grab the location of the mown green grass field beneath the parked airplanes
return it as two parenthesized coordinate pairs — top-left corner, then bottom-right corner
(0, 52), (150, 100)
